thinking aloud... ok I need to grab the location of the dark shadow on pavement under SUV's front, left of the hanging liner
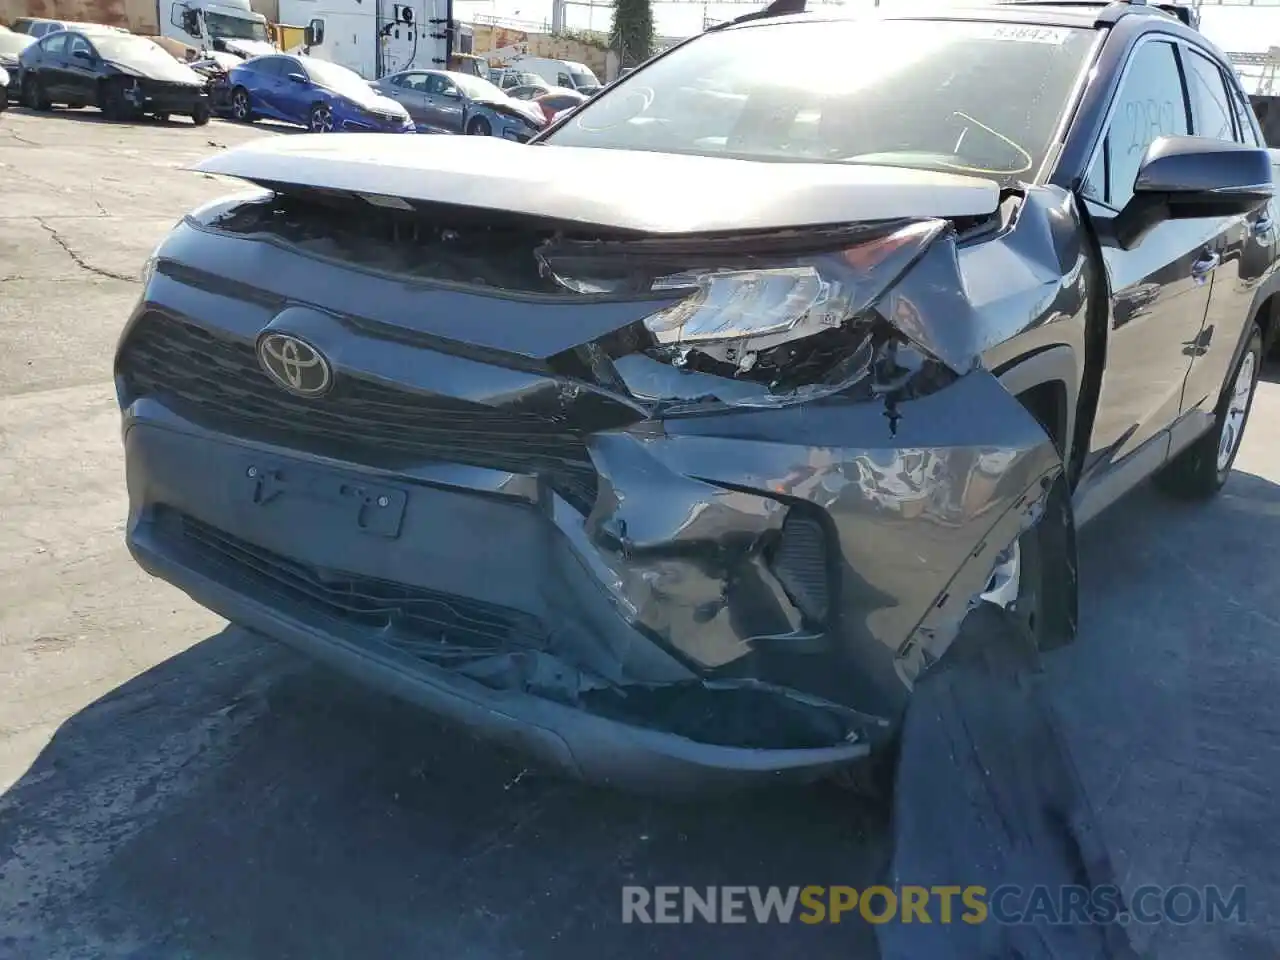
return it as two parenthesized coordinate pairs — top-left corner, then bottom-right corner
(0, 628), (888, 960)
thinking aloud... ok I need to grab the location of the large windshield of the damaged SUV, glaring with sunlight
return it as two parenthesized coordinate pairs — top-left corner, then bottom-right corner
(547, 20), (1093, 180)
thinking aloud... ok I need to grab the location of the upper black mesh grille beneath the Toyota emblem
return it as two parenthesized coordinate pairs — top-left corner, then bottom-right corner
(119, 314), (596, 512)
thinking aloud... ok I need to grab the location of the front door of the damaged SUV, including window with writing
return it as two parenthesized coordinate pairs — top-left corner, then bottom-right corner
(1082, 33), (1221, 472)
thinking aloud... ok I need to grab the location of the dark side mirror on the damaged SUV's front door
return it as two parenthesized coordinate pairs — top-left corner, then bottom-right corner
(1114, 137), (1275, 250)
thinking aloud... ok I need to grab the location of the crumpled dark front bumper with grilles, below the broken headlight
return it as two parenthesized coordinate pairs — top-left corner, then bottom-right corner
(116, 188), (1061, 790)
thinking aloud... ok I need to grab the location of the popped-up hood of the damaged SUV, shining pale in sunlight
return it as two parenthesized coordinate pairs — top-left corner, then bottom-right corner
(195, 133), (1000, 234)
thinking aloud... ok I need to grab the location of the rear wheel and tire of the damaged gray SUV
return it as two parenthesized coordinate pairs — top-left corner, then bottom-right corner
(1155, 324), (1262, 500)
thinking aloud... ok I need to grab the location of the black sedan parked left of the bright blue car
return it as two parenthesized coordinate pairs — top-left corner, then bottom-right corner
(19, 29), (210, 125)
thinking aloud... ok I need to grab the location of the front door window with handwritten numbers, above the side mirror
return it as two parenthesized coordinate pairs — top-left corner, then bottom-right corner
(1082, 41), (1190, 210)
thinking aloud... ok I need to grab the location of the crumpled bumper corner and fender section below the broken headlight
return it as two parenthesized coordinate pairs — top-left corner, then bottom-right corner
(570, 370), (1074, 717)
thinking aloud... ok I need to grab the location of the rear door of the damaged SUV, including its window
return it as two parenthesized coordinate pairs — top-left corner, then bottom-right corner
(1181, 44), (1277, 426)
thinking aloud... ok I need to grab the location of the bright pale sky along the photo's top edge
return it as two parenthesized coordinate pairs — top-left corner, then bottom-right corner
(453, 0), (1280, 52)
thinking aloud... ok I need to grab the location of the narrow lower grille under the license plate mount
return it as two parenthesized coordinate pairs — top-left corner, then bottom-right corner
(165, 508), (547, 663)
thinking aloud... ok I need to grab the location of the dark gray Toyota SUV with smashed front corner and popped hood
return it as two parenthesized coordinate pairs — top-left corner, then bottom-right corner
(115, 4), (1280, 790)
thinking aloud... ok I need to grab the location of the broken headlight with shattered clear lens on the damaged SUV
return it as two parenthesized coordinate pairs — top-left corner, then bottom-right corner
(640, 220), (946, 406)
